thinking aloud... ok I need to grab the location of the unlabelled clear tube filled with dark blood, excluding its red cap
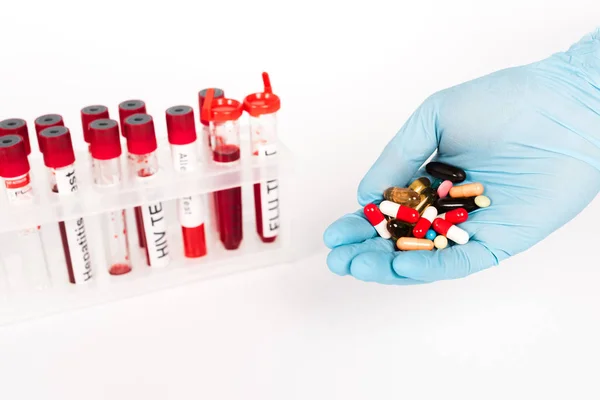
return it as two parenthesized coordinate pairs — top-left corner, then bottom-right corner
(210, 120), (243, 250)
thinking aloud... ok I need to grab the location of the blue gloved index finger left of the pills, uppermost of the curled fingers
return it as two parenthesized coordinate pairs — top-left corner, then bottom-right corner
(323, 210), (377, 249)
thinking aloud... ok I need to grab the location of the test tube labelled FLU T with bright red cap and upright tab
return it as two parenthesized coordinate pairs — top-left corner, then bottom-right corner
(244, 72), (281, 243)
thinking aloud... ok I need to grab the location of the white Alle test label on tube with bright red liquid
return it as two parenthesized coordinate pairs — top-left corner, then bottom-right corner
(171, 143), (204, 228)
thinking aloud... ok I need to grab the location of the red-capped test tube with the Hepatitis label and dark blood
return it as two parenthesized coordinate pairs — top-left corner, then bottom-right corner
(39, 126), (93, 284)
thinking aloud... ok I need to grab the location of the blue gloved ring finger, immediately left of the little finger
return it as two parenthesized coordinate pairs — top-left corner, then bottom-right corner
(350, 251), (427, 285)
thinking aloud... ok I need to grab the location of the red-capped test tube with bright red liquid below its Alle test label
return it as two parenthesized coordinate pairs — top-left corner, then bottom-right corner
(166, 106), (206, 258)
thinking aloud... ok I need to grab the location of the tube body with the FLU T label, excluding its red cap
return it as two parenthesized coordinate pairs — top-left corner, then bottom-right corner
(250, 113), (280, 243)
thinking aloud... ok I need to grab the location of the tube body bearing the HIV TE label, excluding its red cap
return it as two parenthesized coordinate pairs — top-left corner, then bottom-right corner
(128, 152), (171, 268)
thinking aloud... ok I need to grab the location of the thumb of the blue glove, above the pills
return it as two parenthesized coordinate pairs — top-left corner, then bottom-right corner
(358, 95), (441, 206)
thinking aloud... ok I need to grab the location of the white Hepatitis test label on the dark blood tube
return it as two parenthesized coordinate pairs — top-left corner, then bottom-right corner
(55, 166), (93, 283)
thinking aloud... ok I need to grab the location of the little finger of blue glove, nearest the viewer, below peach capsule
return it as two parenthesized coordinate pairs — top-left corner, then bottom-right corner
(393, 241), (498, 282)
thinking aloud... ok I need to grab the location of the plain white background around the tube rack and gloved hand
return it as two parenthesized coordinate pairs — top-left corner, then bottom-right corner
(0, 0), (600, 400)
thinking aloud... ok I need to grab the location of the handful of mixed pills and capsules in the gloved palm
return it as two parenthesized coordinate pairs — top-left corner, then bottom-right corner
(364, 161), (491, 250)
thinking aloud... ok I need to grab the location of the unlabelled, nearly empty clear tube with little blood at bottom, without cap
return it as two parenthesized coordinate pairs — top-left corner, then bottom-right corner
(93, 158), (131, 275)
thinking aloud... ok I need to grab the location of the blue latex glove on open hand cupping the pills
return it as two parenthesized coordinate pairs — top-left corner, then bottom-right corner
(324, 29), (600, 285)
